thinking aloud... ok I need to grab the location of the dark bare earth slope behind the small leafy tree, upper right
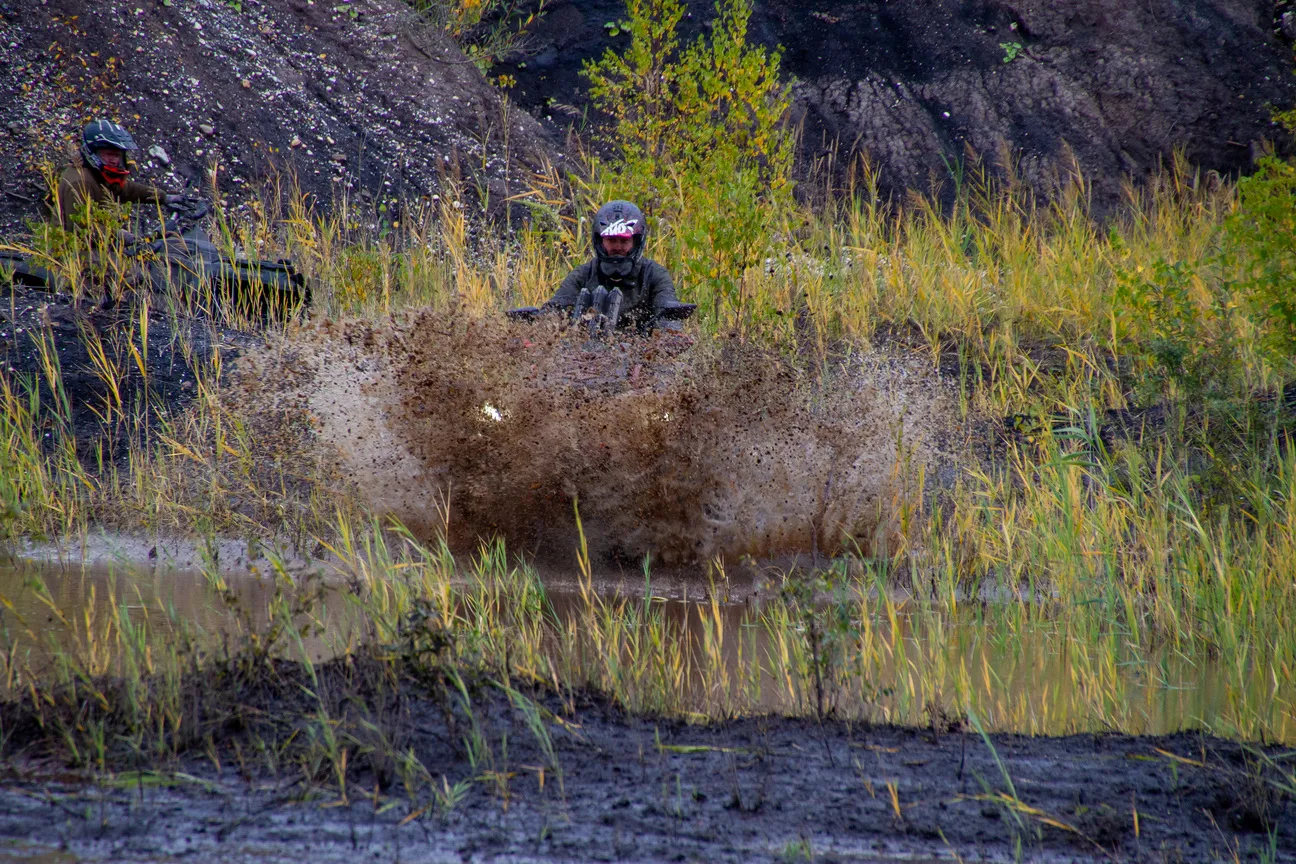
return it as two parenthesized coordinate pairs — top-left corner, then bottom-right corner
(502, 0), (1296, 210)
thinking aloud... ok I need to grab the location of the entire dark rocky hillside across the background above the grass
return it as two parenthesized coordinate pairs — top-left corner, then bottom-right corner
(0, 0), (1296, 232)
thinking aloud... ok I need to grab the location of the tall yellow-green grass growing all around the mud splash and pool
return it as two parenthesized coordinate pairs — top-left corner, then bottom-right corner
(0, 153), (1296, 741)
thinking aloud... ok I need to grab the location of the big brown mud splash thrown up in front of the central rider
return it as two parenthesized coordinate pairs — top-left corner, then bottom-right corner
(241, 310), (955, 563)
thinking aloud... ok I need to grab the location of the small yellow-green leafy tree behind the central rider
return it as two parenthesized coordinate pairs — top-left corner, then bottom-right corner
(584, 0), (793, 331)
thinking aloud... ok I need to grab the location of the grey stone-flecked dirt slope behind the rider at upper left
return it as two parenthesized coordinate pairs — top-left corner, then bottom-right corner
(0, 0), (559, 232)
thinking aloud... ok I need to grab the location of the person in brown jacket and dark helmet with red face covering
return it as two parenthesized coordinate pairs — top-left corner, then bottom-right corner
(53, 120), (181, 241)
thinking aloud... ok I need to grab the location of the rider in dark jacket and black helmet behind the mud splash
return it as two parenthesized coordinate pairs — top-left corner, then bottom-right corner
(544, 201), (679, 330)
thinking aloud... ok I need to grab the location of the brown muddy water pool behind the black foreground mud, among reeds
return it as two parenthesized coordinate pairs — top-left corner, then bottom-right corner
(0, 561), (1296, 744)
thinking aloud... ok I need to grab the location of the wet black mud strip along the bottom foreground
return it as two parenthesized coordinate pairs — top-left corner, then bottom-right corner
(0, 703), (1296, 861)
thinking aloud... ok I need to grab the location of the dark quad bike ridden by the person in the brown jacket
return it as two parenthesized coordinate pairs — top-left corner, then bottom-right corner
(0, 199), (311, 317)
